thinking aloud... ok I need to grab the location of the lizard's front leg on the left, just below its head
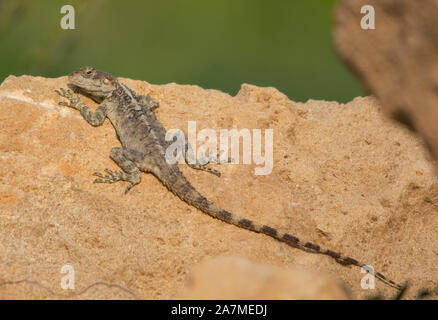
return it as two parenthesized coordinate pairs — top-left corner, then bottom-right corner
(55, 88), (107, 127)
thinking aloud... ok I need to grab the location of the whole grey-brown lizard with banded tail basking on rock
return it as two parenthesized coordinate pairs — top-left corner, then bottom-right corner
(55, 66), (402, 290)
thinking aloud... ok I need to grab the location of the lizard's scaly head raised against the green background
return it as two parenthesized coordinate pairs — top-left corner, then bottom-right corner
(68, 66), (118, 99)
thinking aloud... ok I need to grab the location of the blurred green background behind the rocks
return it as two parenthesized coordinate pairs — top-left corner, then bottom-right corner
(0, 0), (364, 102)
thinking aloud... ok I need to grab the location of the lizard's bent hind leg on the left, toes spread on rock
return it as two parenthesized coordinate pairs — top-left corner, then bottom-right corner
(93, 147), (141, 194)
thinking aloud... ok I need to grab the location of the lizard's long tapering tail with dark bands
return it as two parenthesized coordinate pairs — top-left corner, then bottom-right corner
(160, 167), (403, 290)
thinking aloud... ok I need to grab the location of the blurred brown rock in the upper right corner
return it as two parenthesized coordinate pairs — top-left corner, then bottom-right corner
(335, 0), (438, 175)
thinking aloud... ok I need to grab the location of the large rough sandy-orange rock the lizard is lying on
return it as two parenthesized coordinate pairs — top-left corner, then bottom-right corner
(0, 76), (438, 299)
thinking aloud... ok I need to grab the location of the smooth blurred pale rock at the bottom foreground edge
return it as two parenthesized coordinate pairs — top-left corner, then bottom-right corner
(177, 257), (351, 300)
